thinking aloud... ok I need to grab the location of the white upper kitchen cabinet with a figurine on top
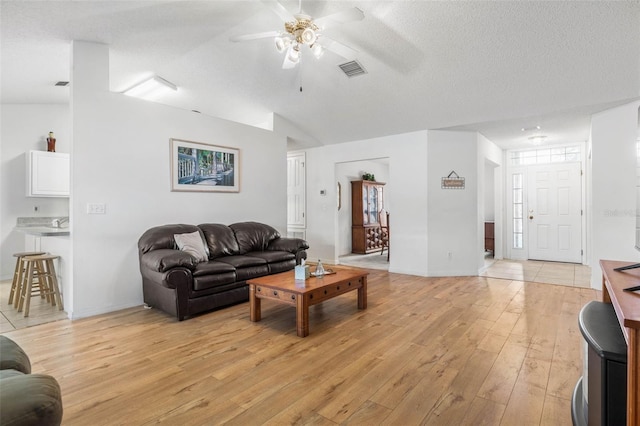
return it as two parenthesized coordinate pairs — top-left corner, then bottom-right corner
(27, 151), (71, 197)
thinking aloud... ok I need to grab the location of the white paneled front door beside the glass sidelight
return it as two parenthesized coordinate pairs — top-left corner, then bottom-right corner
(527, 163), (582, 263)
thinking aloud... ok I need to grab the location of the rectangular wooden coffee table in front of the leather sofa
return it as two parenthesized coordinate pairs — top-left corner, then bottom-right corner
(247, 267), (369, 337)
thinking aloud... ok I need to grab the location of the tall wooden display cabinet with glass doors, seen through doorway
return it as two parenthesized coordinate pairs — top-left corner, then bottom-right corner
(351, 180), (385, 254)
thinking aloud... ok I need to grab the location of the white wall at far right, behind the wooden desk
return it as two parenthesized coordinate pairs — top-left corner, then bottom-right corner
(590, 102), (640, 289)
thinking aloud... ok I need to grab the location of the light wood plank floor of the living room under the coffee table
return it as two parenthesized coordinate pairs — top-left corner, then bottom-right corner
(4, 271), (600, 426)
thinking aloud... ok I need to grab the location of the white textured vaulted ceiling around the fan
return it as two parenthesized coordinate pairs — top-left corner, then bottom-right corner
(0, 0), (640, 148)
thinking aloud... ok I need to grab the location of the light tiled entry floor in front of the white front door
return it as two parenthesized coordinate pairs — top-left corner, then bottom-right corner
(480, 259), (591, 288)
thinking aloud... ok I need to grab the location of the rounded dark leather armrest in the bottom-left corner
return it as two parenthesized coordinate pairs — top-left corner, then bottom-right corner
(0, 374), (62, 425)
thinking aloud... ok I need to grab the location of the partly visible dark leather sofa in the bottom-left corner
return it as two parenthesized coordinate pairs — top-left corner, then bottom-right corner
(0, 335), (62, 426)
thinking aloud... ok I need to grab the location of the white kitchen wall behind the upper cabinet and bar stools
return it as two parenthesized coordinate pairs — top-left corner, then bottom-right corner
(0, 104), (71, 280)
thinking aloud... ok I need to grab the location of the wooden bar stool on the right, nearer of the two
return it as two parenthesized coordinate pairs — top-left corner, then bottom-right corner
(18, 254), (64, 317)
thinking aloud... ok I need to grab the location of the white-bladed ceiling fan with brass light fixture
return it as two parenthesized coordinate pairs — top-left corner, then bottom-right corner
(230, 0), (364, 69)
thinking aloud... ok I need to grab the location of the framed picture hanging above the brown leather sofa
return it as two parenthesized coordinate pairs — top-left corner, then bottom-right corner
(169, 138), (240, 192)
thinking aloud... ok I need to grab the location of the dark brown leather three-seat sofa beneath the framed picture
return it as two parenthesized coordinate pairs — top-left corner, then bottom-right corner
(138, 222), (309, 321)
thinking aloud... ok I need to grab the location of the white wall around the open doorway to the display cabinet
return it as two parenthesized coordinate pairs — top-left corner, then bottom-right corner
(306, 131), (427, 275)
